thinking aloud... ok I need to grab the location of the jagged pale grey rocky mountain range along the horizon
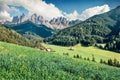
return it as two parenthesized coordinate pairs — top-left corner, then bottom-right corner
(4, 14), (81, 29)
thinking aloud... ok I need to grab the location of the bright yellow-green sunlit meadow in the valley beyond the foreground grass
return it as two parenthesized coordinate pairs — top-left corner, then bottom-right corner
(43, 44), (120, 62)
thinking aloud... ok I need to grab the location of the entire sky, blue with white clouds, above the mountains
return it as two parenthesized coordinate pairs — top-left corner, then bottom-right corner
(0, 0), (120, 21)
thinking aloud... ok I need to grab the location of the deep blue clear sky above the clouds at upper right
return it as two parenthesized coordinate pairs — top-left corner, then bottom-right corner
(44, 0), (120, 13)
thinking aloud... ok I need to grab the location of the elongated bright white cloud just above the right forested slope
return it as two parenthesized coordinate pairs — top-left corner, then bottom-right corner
(79, 5), (110, 20)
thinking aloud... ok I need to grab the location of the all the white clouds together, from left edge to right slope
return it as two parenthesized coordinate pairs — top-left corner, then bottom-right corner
(0, 0), (110, 21)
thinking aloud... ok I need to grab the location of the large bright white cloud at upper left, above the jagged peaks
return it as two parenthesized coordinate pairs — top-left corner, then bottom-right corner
(2, 0), (63, 19)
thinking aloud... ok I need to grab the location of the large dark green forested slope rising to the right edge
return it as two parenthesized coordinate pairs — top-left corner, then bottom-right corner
(45, 6), (120, 46)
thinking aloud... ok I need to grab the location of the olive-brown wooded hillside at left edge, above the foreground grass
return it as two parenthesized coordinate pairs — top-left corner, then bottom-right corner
(0, 26), (42, 48)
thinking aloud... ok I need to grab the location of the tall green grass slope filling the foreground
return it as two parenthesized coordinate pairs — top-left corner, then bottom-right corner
(0, 42), (120, 80)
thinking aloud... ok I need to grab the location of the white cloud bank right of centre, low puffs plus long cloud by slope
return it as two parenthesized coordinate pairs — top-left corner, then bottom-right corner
(65, 4), (110, 21)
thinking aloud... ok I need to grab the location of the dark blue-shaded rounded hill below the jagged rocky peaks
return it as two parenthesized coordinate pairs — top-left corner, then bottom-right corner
(10, 21), (53, 38)
